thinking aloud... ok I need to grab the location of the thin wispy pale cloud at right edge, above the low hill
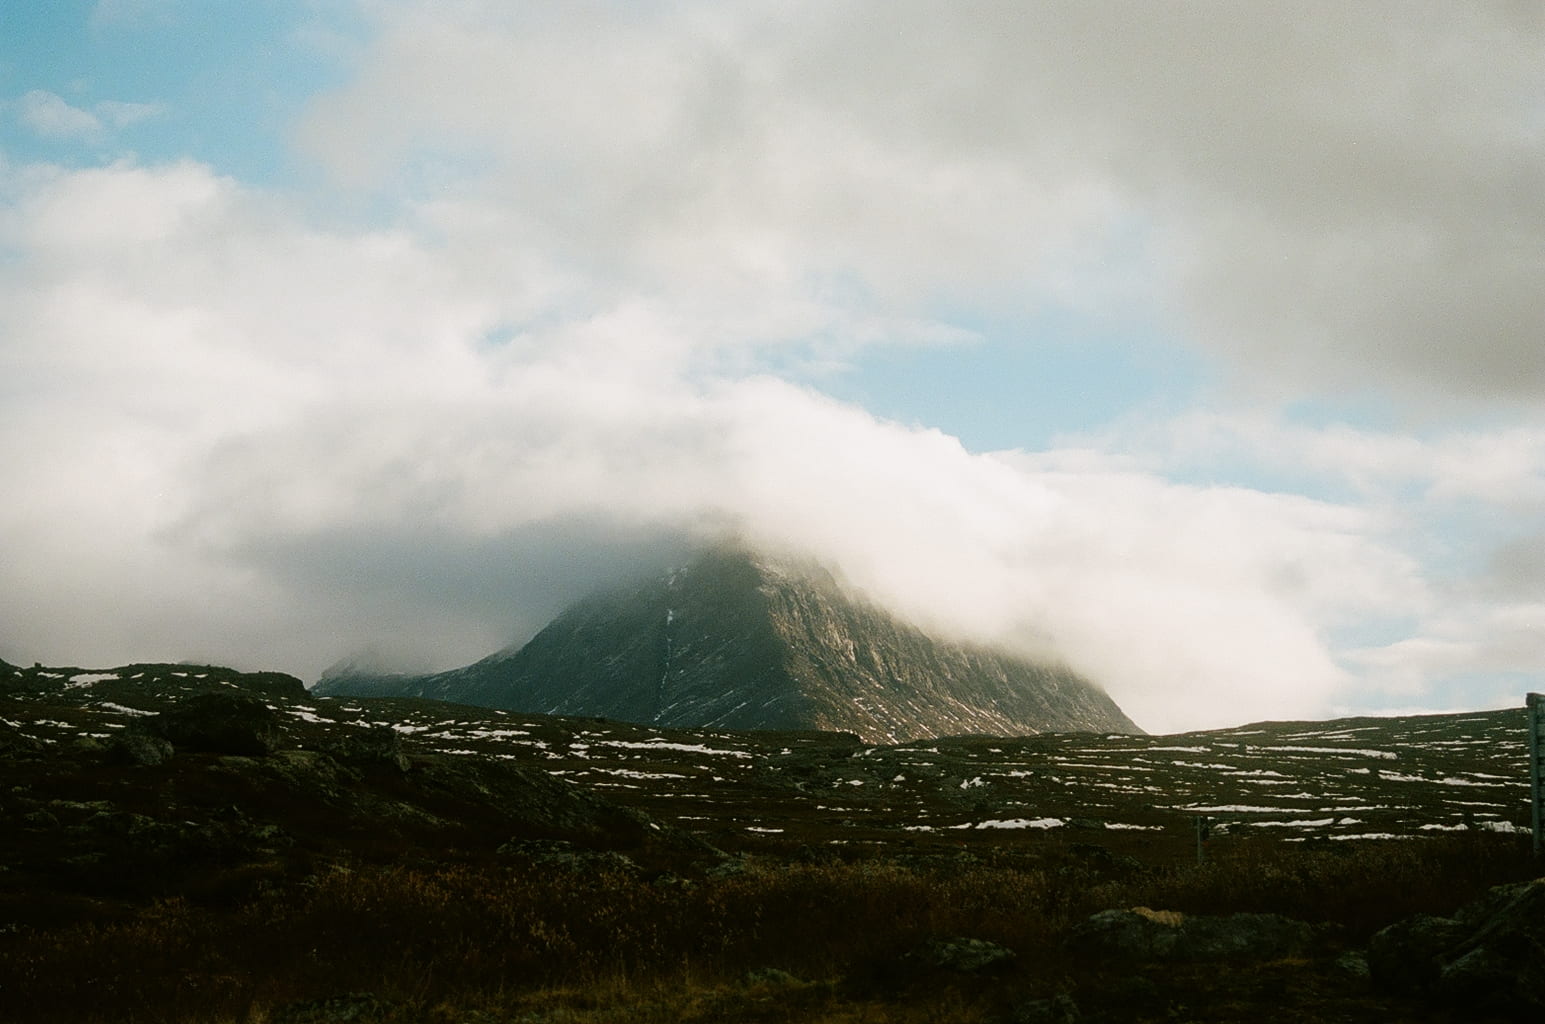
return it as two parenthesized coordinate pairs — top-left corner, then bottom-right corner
(1089, 412), (1545, 709)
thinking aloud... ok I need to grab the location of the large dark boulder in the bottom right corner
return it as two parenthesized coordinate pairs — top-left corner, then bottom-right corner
(1367, 879), (1545, 1021)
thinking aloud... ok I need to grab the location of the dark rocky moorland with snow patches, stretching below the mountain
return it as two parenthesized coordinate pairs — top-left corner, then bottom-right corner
(0, 664), (1545, 1024)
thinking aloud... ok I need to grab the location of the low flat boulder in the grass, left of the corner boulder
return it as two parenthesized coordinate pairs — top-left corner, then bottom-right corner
(1068, 907), (1315, 962)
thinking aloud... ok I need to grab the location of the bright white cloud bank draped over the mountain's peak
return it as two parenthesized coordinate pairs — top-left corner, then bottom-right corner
(0, 164), (1421, 729)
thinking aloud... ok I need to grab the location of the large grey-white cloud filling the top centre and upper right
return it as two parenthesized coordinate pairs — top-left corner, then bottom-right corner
(304, 0), (1545, 406)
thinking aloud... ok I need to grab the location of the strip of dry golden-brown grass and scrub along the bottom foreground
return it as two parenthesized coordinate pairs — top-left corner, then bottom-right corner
(0, 839), (1530, 1024)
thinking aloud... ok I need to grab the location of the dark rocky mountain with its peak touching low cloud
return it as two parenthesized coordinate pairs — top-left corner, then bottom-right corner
(315, 550), (1142, 743)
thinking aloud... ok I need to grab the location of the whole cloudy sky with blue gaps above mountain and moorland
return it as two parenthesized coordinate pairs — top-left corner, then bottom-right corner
(0, 0), (1545, 732)
